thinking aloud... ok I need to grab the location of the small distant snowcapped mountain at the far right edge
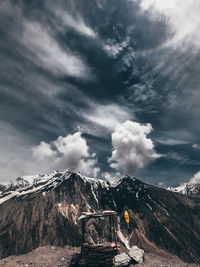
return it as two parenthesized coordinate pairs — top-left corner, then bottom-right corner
(168, 183), (200, 197)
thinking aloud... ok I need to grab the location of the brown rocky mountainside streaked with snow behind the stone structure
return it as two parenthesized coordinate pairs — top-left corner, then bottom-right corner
(0, 171), (200, 263)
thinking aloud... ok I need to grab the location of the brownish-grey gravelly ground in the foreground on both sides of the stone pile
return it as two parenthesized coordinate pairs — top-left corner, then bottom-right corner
(0, 246), (200, 267)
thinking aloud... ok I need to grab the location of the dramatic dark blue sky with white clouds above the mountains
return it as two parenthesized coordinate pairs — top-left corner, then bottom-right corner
(0, 0), (200, 187)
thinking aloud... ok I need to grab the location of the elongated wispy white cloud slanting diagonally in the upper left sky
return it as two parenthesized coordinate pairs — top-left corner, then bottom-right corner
(21, 21), (92, 79)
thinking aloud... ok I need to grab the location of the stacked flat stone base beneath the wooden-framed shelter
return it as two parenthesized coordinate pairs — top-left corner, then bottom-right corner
(81, 243), (117, 267)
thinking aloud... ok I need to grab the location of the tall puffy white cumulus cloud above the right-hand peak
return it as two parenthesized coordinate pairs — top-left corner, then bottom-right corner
(108, 121), (161, 174)
